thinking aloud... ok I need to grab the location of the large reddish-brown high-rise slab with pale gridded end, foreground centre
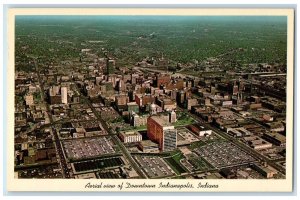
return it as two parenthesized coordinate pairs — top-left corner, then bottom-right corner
(147, 116), (177, 151)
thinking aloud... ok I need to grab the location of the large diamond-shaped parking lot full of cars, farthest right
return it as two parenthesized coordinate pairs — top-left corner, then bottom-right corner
(194, 142), (255, 168)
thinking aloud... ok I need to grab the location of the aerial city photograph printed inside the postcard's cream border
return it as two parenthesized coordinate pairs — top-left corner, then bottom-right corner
(14, 15), (292, 179)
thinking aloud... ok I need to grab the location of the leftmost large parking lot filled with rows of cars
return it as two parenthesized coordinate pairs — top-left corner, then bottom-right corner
(62, 137), (115, 159)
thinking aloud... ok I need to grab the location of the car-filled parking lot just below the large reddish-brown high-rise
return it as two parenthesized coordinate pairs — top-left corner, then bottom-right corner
(134, 156), (175, 178)
